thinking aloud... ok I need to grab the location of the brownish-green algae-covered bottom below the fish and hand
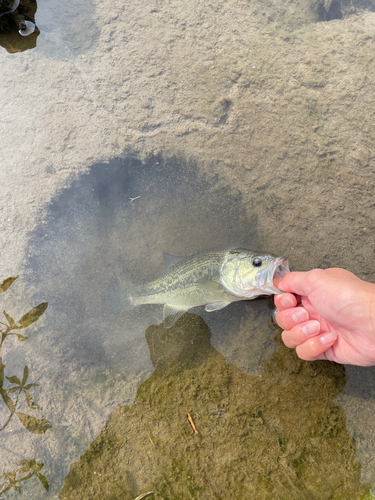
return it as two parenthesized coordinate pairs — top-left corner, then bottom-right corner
(60, 314), (368, 500)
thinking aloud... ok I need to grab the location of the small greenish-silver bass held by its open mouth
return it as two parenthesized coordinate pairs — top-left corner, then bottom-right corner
(103, 248), (290, 328)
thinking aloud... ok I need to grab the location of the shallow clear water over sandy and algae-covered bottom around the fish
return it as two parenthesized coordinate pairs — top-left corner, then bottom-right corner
(0, 0), (375, 500)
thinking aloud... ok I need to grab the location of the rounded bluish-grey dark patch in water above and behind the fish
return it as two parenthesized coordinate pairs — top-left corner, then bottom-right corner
(26, 155), (265, 376)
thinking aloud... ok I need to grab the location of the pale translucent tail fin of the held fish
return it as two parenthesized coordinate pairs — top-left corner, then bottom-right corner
(102, 276), (134, 316)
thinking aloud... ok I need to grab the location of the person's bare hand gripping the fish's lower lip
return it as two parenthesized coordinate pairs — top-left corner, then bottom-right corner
(274, 268), (375, 366)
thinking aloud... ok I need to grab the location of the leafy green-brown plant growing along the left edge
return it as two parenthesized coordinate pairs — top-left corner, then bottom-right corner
(0, 276), (52, 495)
